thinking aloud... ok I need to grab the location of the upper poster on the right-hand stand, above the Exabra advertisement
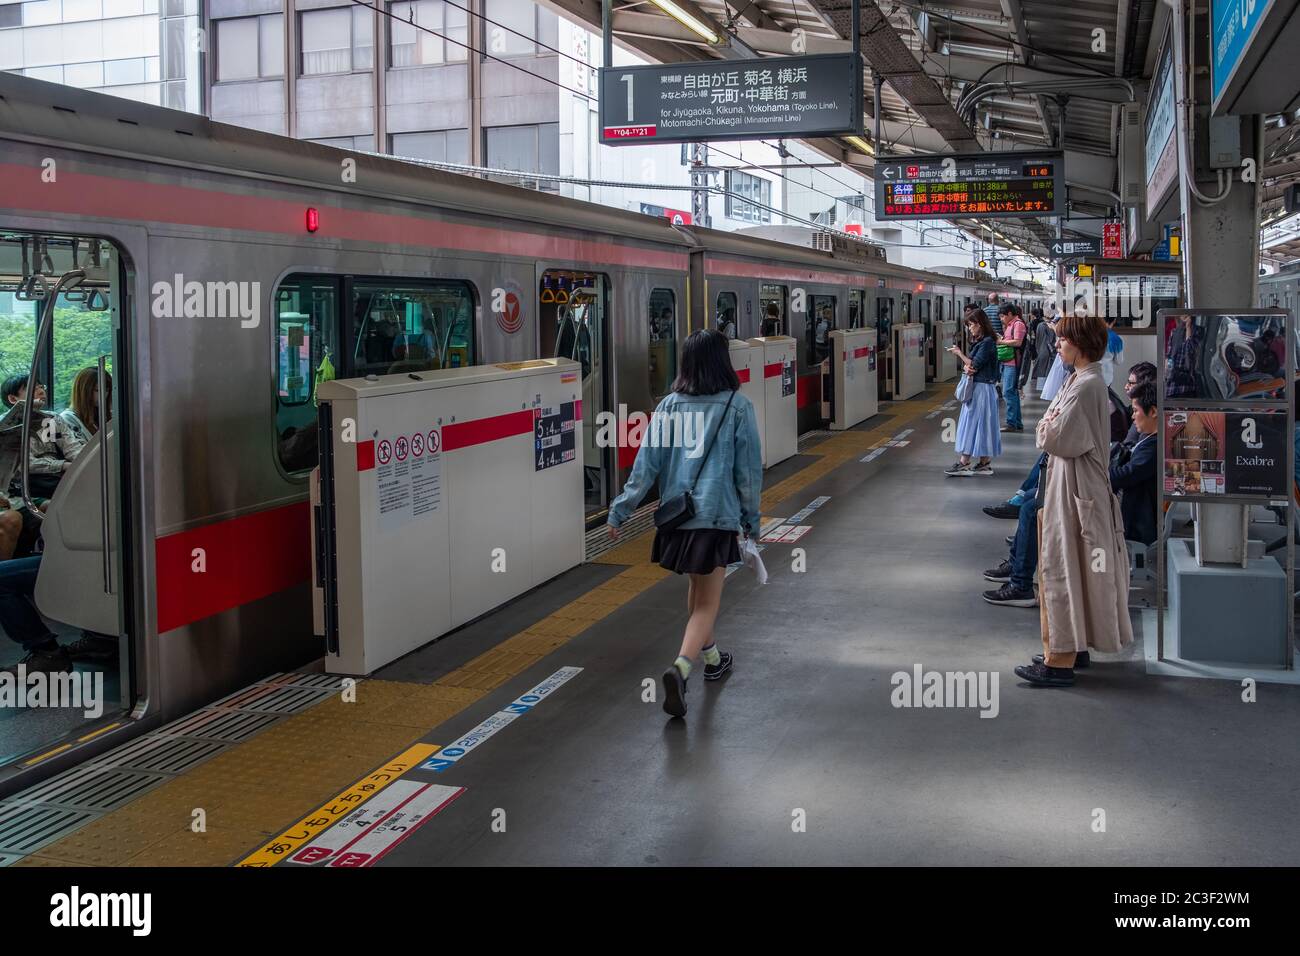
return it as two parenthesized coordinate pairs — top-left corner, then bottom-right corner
(1165, 315), (1295, 402)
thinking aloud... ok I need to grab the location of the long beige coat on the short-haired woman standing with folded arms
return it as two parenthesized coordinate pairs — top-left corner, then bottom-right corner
(1037, 362), (1132, 653)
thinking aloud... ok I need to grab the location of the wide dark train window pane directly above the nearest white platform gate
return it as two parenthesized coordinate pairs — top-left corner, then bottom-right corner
(348, 280), (475, 375)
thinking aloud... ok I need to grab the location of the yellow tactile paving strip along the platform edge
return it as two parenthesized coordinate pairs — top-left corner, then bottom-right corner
(13, 392), (940, 866)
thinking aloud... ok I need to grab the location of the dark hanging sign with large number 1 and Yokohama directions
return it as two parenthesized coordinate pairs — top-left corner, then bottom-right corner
(601, 53), (863, 146)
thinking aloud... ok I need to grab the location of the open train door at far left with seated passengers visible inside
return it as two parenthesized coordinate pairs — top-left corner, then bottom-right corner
(0, 233), (132, 767)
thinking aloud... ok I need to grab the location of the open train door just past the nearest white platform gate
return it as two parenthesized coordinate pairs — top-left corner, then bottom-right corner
(538, 269), (614, 519)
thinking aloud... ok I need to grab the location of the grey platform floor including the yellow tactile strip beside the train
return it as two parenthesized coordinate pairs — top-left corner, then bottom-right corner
(10, 385), (1300, 865)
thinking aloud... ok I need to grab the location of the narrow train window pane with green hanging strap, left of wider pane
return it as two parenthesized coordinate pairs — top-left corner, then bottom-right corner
(276, 276), (338, 473)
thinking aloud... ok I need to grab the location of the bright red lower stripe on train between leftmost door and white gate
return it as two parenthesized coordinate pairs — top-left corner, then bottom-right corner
(153, 501), (312, 633)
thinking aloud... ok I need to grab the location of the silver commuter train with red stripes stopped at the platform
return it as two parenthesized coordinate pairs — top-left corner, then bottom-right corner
(0, 74), (1043, 795)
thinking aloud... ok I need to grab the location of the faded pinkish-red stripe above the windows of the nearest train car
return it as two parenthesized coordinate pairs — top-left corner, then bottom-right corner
(0, 163), (686, 278)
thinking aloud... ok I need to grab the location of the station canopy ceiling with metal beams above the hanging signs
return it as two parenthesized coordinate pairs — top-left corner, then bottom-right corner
(545, 0), (1300, 265)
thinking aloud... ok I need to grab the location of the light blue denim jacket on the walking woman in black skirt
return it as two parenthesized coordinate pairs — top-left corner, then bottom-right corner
(610, 392), (763, 535)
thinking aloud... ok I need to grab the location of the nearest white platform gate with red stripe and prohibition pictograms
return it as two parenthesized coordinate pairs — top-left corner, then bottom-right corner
(312, 359), (585, 674)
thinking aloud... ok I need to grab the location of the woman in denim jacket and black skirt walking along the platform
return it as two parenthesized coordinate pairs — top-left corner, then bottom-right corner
(607, 329), (763, 717)
